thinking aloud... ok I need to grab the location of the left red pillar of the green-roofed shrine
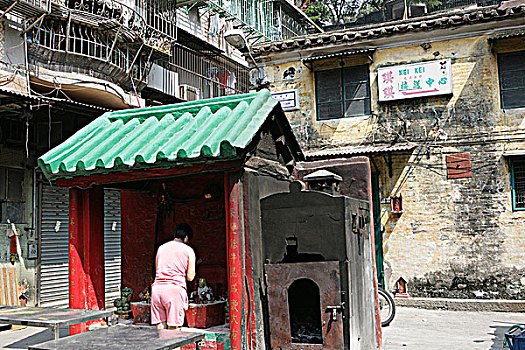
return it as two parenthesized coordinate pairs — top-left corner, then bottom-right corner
(69, 188), (105, 334)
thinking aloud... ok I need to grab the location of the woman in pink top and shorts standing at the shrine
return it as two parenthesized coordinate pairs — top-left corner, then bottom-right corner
(151, 224), (195, 329)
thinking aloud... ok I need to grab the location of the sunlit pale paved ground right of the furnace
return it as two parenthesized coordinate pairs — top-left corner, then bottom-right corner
(383, 307), (525, 350)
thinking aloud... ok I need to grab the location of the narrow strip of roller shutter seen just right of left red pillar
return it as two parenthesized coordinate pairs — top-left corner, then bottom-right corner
(104, 190), (121, 304)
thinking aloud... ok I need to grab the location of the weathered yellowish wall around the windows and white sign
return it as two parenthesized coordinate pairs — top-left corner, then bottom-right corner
(267, 36), (525, 298)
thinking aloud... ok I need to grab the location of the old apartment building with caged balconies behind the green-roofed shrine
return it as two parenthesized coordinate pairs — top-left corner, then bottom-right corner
(0, 0), (320, 306)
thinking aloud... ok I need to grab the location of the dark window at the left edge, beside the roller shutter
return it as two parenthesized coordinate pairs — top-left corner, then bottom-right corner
(0, 167), (24, 224)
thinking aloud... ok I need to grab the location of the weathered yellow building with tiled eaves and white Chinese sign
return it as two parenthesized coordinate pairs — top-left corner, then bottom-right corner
(252, 1), (525, 299)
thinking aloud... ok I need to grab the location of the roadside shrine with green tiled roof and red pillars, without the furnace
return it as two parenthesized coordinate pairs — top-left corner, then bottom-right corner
(38, 90), (303, 350)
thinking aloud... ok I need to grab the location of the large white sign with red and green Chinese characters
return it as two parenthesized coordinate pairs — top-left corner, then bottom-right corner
(377, 59), (452, 101)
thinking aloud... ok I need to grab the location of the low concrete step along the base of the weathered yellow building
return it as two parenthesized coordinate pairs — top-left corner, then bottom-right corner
(394, 297), (525, 312)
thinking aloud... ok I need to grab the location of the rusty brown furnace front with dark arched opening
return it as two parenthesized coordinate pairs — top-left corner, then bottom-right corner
(265, 261), (344, 350)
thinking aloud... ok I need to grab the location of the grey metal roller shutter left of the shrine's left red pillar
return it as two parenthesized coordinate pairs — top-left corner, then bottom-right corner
(39, 184), (69, 307)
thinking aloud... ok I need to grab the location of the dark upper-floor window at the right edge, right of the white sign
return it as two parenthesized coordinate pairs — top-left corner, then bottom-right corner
(498, 51), (525, 108)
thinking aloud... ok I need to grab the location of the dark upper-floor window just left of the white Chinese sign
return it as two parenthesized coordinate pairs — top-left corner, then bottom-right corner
(315, 65), (370, 120)
